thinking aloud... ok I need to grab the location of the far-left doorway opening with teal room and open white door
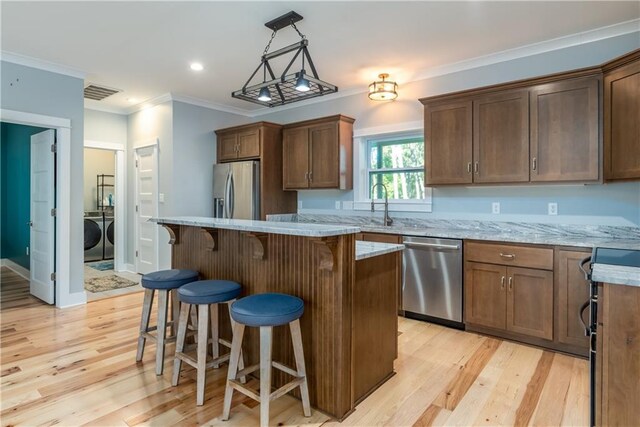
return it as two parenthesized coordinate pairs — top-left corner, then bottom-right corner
(0, 122), (56, 304)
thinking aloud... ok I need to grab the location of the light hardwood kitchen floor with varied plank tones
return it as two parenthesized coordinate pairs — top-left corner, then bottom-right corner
(0, 290), (588, 426)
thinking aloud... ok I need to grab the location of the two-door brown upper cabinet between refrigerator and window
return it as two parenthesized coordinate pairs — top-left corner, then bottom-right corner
(282, 115), (354, 190)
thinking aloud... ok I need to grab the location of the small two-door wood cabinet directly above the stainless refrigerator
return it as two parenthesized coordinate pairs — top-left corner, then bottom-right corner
(216, 122), (262, 162)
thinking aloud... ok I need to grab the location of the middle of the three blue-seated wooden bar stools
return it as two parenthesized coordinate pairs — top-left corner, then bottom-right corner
(171, 280), (244, 405)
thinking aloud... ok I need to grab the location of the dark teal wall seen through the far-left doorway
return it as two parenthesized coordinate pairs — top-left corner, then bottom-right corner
(0, 123), (46, 269)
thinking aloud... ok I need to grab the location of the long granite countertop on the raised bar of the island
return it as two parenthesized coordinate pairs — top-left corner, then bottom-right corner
(149, 216), (360, 237)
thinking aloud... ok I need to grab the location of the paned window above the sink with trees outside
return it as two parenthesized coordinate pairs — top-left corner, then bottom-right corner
(365, 135), (425, 201)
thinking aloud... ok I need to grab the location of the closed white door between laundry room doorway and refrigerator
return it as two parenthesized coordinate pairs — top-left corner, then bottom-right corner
(135, 145), (158, 274)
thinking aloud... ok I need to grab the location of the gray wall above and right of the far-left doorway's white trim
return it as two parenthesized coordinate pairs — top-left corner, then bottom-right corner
(0, 61), (84, 293)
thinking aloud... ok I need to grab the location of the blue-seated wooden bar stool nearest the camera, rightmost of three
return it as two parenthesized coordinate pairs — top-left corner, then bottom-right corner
(222, 293), (311, 427)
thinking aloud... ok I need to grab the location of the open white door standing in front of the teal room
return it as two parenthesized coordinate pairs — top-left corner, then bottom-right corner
(29, 129), (55, 304)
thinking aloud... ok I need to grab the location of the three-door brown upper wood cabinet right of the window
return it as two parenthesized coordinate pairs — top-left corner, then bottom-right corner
(420, 69), (602, 185)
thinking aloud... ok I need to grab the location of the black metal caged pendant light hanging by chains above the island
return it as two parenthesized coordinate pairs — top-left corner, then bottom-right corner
(231, 11), (338, 107)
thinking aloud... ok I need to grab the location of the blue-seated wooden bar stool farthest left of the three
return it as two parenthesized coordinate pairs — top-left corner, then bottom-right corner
(136, 269), (198, 375)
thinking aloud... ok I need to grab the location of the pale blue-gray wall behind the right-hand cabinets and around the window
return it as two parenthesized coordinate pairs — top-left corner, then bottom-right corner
(250, 32), (640, 225)
